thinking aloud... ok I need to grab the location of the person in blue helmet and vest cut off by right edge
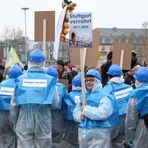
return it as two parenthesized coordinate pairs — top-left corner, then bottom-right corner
(125, 67), (148, 148)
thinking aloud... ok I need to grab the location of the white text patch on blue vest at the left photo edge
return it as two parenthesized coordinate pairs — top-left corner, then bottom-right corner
(0, 87), (14, 96)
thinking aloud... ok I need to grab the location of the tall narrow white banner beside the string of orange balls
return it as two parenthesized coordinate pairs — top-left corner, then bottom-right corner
(53, 6), (67, 60)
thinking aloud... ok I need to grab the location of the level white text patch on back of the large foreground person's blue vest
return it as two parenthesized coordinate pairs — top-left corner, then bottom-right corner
(23, 79), (47, 87)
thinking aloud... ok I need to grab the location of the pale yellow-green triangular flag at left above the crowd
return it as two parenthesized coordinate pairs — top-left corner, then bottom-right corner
(5, 47), (21, 68)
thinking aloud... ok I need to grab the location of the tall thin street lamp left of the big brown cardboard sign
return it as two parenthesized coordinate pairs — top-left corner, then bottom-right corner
(21, 7), (29, 64)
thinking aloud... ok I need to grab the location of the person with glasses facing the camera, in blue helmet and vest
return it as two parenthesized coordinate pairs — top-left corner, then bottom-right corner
(73, 69), (119, 148)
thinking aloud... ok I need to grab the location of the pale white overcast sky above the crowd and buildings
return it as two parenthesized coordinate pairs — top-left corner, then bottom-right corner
(0, 0), (148, 39)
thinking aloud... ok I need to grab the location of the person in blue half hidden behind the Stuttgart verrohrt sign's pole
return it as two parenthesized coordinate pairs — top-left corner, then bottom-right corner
(64, 74), (82, 148)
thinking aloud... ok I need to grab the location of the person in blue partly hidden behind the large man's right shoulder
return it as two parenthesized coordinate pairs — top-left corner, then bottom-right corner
(47, 66), (68, 148)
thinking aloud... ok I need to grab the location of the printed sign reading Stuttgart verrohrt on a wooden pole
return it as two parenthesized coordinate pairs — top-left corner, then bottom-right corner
(69, 12), (92, 48)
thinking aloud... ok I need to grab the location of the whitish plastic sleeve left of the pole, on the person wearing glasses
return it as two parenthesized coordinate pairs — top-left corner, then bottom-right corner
(73, 103), (83, 122)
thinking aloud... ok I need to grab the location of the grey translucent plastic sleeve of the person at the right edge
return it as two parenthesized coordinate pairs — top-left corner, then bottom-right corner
(125, 97), (138, 141)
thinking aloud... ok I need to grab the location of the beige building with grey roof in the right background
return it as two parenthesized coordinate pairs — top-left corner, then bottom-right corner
(98, 27), (148, 64)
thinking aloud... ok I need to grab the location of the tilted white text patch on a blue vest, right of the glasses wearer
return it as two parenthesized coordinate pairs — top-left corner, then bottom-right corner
(114, 88), (133, 100)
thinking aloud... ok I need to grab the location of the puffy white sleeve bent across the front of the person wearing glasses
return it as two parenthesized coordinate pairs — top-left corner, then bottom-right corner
(83, 97), (113, 120)
